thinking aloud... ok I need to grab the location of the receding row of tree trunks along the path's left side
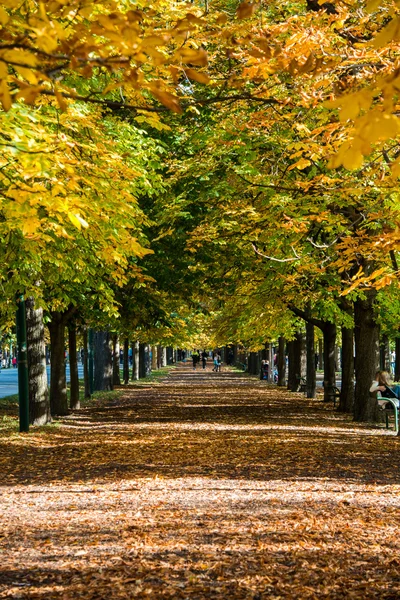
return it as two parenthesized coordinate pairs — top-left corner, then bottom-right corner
(26, 297), (170, 425)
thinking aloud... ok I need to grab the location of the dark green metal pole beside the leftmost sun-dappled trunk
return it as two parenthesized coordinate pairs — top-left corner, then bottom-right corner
(16, 294), (29, 433)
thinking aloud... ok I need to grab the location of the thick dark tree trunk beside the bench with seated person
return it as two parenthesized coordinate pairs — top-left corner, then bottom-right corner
(354, 290), (379, 422)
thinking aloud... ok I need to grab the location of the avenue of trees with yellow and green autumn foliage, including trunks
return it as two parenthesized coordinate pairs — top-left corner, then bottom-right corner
(0, 0), (400, 432)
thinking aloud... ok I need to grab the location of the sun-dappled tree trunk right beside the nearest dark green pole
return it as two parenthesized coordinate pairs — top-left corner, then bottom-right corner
(25, 297), (51, 425)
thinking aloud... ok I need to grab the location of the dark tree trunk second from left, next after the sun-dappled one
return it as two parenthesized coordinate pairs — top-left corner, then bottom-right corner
(48, 311), (68, 416)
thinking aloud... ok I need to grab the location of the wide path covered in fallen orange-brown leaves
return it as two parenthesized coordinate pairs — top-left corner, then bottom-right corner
(0, 366), (400, 600)
